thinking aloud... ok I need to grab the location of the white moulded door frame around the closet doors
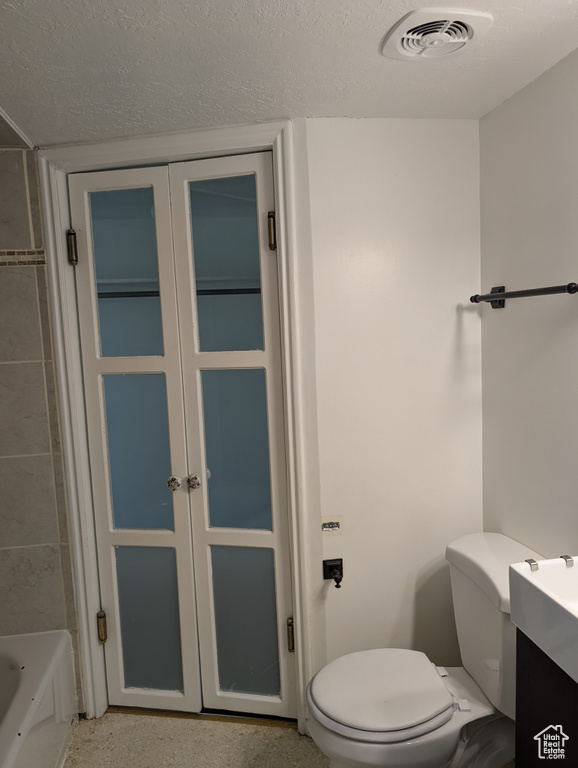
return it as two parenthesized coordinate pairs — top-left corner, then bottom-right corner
(40, 121), (324, 730)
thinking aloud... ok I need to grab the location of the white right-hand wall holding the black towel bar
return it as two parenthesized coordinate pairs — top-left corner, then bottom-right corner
(480, 51), (578, 557)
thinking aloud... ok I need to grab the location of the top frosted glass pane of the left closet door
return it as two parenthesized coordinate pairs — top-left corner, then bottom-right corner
(90, 187), (163, 357)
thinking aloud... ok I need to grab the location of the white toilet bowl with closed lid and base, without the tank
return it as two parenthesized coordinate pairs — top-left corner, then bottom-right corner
(307, 648), (514, 768)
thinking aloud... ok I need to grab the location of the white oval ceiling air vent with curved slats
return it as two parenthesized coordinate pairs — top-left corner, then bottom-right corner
(381, 8), (493, 61)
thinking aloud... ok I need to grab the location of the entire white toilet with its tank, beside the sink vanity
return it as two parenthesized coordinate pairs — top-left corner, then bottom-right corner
(307, 533), (542, 768)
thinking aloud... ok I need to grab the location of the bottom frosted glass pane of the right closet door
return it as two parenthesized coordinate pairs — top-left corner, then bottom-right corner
(211, 546), (281, 696)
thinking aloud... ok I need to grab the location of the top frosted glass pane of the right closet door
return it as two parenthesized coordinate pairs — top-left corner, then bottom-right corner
(189, 175), (263, 352)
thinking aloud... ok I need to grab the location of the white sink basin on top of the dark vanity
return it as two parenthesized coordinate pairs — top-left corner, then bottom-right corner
(510, 556), (578, 682)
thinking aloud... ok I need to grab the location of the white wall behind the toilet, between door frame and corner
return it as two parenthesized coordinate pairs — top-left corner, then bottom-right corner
(306, 119), (482, 664)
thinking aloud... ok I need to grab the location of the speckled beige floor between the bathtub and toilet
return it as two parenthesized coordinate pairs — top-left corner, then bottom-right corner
(64, 711), (329, 768)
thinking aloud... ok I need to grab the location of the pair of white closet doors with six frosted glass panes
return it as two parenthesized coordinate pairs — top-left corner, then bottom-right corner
(69, 153), (295, 717)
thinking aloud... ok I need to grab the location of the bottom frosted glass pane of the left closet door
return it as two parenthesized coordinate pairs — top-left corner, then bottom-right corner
(116, 547), (183, 691)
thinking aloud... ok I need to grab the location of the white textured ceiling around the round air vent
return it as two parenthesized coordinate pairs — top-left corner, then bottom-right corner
(0, 0), (578, 146)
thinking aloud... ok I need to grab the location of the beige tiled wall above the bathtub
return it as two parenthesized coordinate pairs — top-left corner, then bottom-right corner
(0, 140), (77, 708)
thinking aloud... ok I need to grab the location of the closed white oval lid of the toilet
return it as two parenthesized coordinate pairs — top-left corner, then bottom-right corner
(310, 648), (453, 732)
